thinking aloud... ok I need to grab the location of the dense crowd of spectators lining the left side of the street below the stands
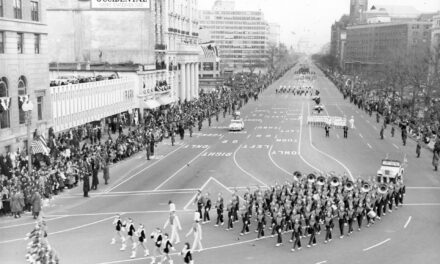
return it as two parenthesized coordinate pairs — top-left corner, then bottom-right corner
(0, 65), (296, 217)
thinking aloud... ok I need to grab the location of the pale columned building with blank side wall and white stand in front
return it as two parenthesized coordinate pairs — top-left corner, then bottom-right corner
(47, 0), (199, 131)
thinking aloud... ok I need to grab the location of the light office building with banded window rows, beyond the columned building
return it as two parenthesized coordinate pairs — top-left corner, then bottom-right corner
(200, 0), (269, 71)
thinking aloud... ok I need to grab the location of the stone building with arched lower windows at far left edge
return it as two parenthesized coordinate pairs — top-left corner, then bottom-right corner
(0, 0), (51, 154)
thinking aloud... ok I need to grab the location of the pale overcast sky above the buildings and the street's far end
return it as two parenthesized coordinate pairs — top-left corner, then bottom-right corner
(199, 0), (440, 51)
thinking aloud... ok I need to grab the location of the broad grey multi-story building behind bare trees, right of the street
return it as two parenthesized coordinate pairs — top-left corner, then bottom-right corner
(344, 21), (432, 70)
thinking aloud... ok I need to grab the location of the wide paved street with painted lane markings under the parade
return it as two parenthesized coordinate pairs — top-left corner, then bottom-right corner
(0, 62), (440, 264)
